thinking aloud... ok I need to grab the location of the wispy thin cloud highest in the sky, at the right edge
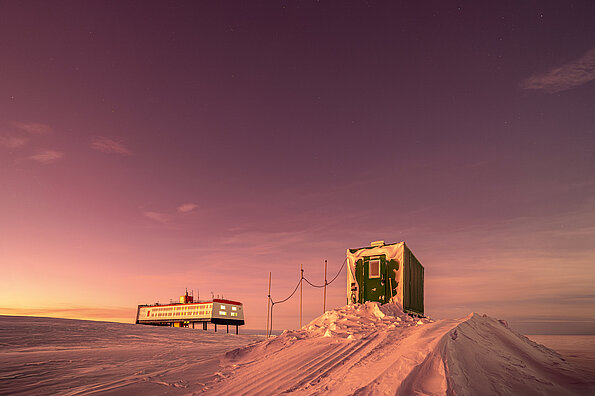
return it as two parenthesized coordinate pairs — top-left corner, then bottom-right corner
(520, 47), (595, 93)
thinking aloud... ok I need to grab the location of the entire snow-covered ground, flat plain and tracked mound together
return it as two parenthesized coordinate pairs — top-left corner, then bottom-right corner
(0, 303), (595, 396)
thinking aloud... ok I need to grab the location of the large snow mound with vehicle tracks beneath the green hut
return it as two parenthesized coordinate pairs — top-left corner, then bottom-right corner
(204, 303), (594, 395)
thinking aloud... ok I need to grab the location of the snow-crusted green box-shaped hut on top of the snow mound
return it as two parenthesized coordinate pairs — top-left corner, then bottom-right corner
(347, 241), (424, 315)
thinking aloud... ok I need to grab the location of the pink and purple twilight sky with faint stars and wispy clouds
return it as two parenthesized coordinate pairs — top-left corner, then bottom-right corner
(0, 1), (595, 333)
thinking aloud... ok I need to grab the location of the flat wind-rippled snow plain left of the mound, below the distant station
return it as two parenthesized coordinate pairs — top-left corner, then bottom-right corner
(0, 316), (262, 395)
